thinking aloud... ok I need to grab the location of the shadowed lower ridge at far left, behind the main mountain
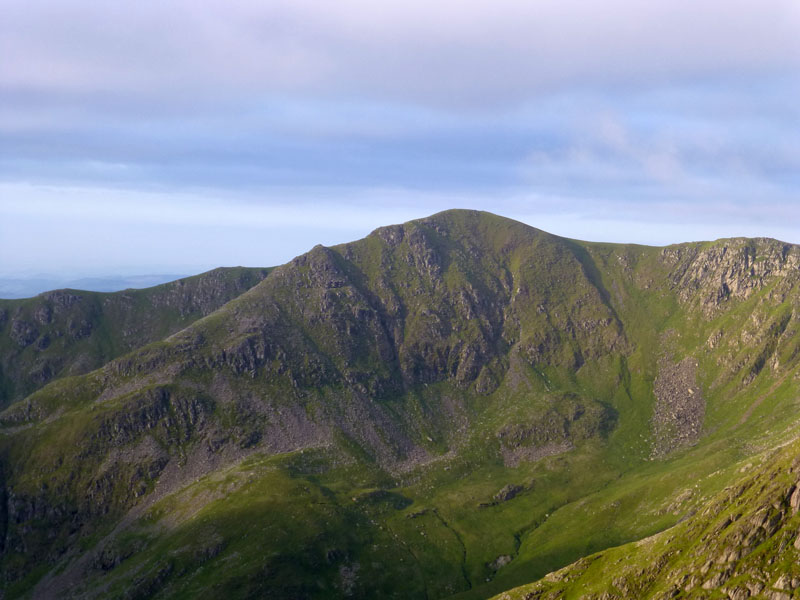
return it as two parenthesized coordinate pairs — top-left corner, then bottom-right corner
(0, 267), (268, 407)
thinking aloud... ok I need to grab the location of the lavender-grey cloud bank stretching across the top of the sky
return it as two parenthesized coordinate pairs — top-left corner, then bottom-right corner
(0, 0), (800, 105)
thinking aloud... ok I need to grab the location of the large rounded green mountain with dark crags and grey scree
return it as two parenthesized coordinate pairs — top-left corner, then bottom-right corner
(0, 211), (800, 598)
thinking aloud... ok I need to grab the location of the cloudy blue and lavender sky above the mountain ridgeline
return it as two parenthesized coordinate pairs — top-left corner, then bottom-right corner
(0, 0), (800, 277)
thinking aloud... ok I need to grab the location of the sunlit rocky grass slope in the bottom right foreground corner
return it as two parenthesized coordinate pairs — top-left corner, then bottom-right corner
(496, 440), (800, 600)
